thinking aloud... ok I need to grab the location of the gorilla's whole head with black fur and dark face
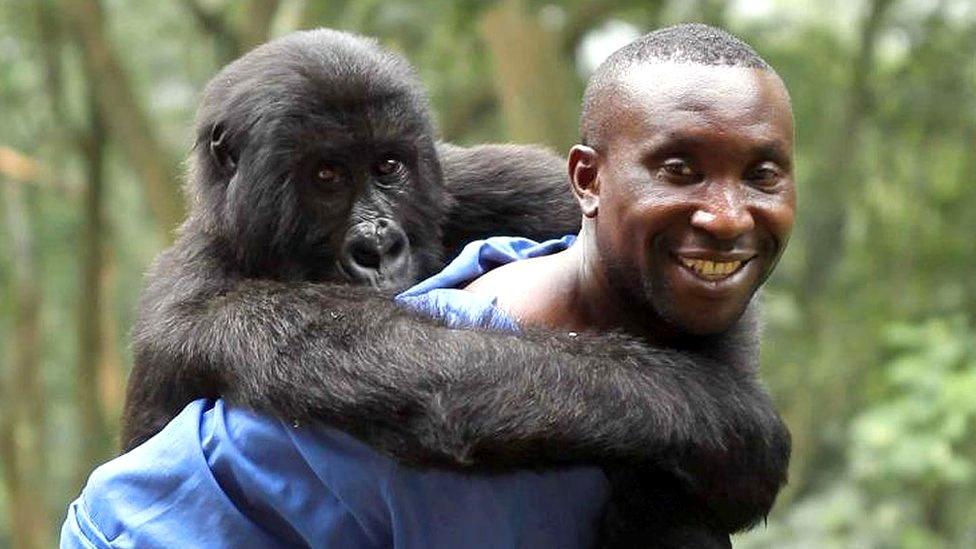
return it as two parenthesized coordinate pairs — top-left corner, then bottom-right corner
(185, 29), (448, 289)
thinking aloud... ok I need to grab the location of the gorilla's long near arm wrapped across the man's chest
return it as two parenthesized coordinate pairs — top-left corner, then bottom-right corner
(123, 239), (789, 530)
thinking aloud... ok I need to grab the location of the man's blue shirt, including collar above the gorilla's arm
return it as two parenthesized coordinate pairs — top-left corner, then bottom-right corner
(61, 237), (608, 548)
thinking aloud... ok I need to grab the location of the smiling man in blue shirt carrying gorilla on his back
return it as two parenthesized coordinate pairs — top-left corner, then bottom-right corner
(62, 25), (795, 547)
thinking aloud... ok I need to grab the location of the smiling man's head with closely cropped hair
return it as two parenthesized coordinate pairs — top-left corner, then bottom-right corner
(569, 25), (795, 334)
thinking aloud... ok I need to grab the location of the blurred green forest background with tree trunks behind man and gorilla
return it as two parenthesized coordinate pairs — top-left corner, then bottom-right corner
(0, 0), (976, 549)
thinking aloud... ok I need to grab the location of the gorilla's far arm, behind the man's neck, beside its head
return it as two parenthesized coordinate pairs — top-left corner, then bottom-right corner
(437, 143), (581, 257)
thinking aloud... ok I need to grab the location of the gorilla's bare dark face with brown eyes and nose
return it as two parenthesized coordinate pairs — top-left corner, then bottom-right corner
(290, 123), (443, 290)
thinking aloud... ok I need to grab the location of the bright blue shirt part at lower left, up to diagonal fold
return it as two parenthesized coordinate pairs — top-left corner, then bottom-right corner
(61, 400), (308, 548)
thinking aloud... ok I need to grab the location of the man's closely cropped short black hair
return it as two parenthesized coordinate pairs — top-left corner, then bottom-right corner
(580, 23), (776, 147)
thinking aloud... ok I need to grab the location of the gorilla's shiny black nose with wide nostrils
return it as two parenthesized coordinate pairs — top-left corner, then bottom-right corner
(342, 219), (410, 286)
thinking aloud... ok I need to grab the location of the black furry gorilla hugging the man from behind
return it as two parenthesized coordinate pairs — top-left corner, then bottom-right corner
(122, 29), (790, 546)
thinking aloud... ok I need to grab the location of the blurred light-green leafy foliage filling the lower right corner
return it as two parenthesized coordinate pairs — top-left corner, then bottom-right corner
(737, 316), (976, 549)
